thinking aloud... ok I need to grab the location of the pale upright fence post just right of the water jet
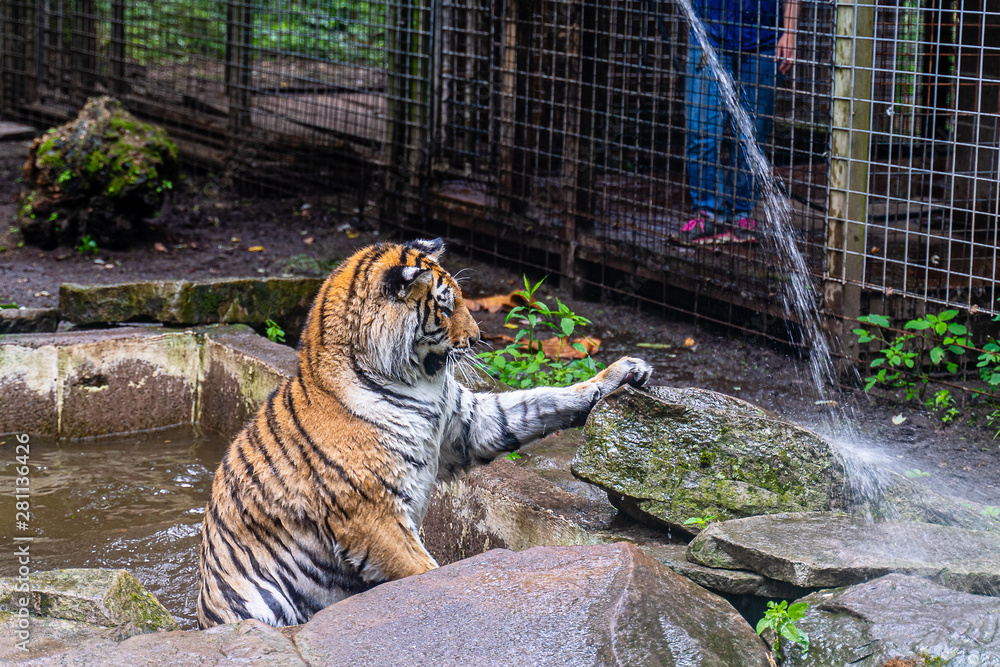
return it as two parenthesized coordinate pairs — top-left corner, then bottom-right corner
(824, 0), (875, 366)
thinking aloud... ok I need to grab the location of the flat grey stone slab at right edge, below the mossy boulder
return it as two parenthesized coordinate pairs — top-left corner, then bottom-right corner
(687, 512), (1000, 595)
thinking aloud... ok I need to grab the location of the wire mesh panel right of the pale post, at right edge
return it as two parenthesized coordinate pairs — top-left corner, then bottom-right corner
(837, 0), (1000, 322)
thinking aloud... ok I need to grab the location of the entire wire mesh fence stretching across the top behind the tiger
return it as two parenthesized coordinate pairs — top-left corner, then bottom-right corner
(7, 0), (1000, 350)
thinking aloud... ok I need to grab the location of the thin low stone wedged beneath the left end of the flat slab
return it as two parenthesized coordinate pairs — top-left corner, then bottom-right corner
(638, 544), (809, 600)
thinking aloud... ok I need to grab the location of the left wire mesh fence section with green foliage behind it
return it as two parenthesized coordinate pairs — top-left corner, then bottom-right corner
(3, 0), (430, 196)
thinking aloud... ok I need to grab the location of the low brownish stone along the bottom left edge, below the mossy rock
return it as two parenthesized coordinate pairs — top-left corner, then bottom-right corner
(0, 620), (304, 667)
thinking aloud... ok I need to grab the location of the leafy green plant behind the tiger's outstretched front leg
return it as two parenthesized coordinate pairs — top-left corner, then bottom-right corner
(477, 276), (604, 389)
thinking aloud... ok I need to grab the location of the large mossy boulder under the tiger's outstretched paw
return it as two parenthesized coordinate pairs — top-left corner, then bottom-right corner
(573, 387), (846, 532)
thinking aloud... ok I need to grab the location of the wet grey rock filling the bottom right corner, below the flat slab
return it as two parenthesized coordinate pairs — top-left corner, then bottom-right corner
(784, 574), (1000, 667)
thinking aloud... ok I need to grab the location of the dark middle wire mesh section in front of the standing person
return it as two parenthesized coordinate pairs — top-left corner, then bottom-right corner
(412, 0), (833, 340)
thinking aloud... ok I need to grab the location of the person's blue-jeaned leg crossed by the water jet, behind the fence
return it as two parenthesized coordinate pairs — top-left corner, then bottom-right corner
(730, 50), (780, 223)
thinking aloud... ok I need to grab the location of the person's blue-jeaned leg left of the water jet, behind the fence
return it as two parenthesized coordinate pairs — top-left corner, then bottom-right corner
(684, 37), (726, 217)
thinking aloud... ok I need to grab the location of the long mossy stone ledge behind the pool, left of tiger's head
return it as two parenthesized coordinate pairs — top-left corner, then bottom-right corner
(59, 278), (323, 334)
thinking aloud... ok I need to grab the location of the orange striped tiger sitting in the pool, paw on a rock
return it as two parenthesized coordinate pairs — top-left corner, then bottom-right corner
(197, 239), (651, 628)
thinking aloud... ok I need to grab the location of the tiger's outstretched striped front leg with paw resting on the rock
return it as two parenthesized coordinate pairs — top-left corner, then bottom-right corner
(439, 357), (653, 479)
